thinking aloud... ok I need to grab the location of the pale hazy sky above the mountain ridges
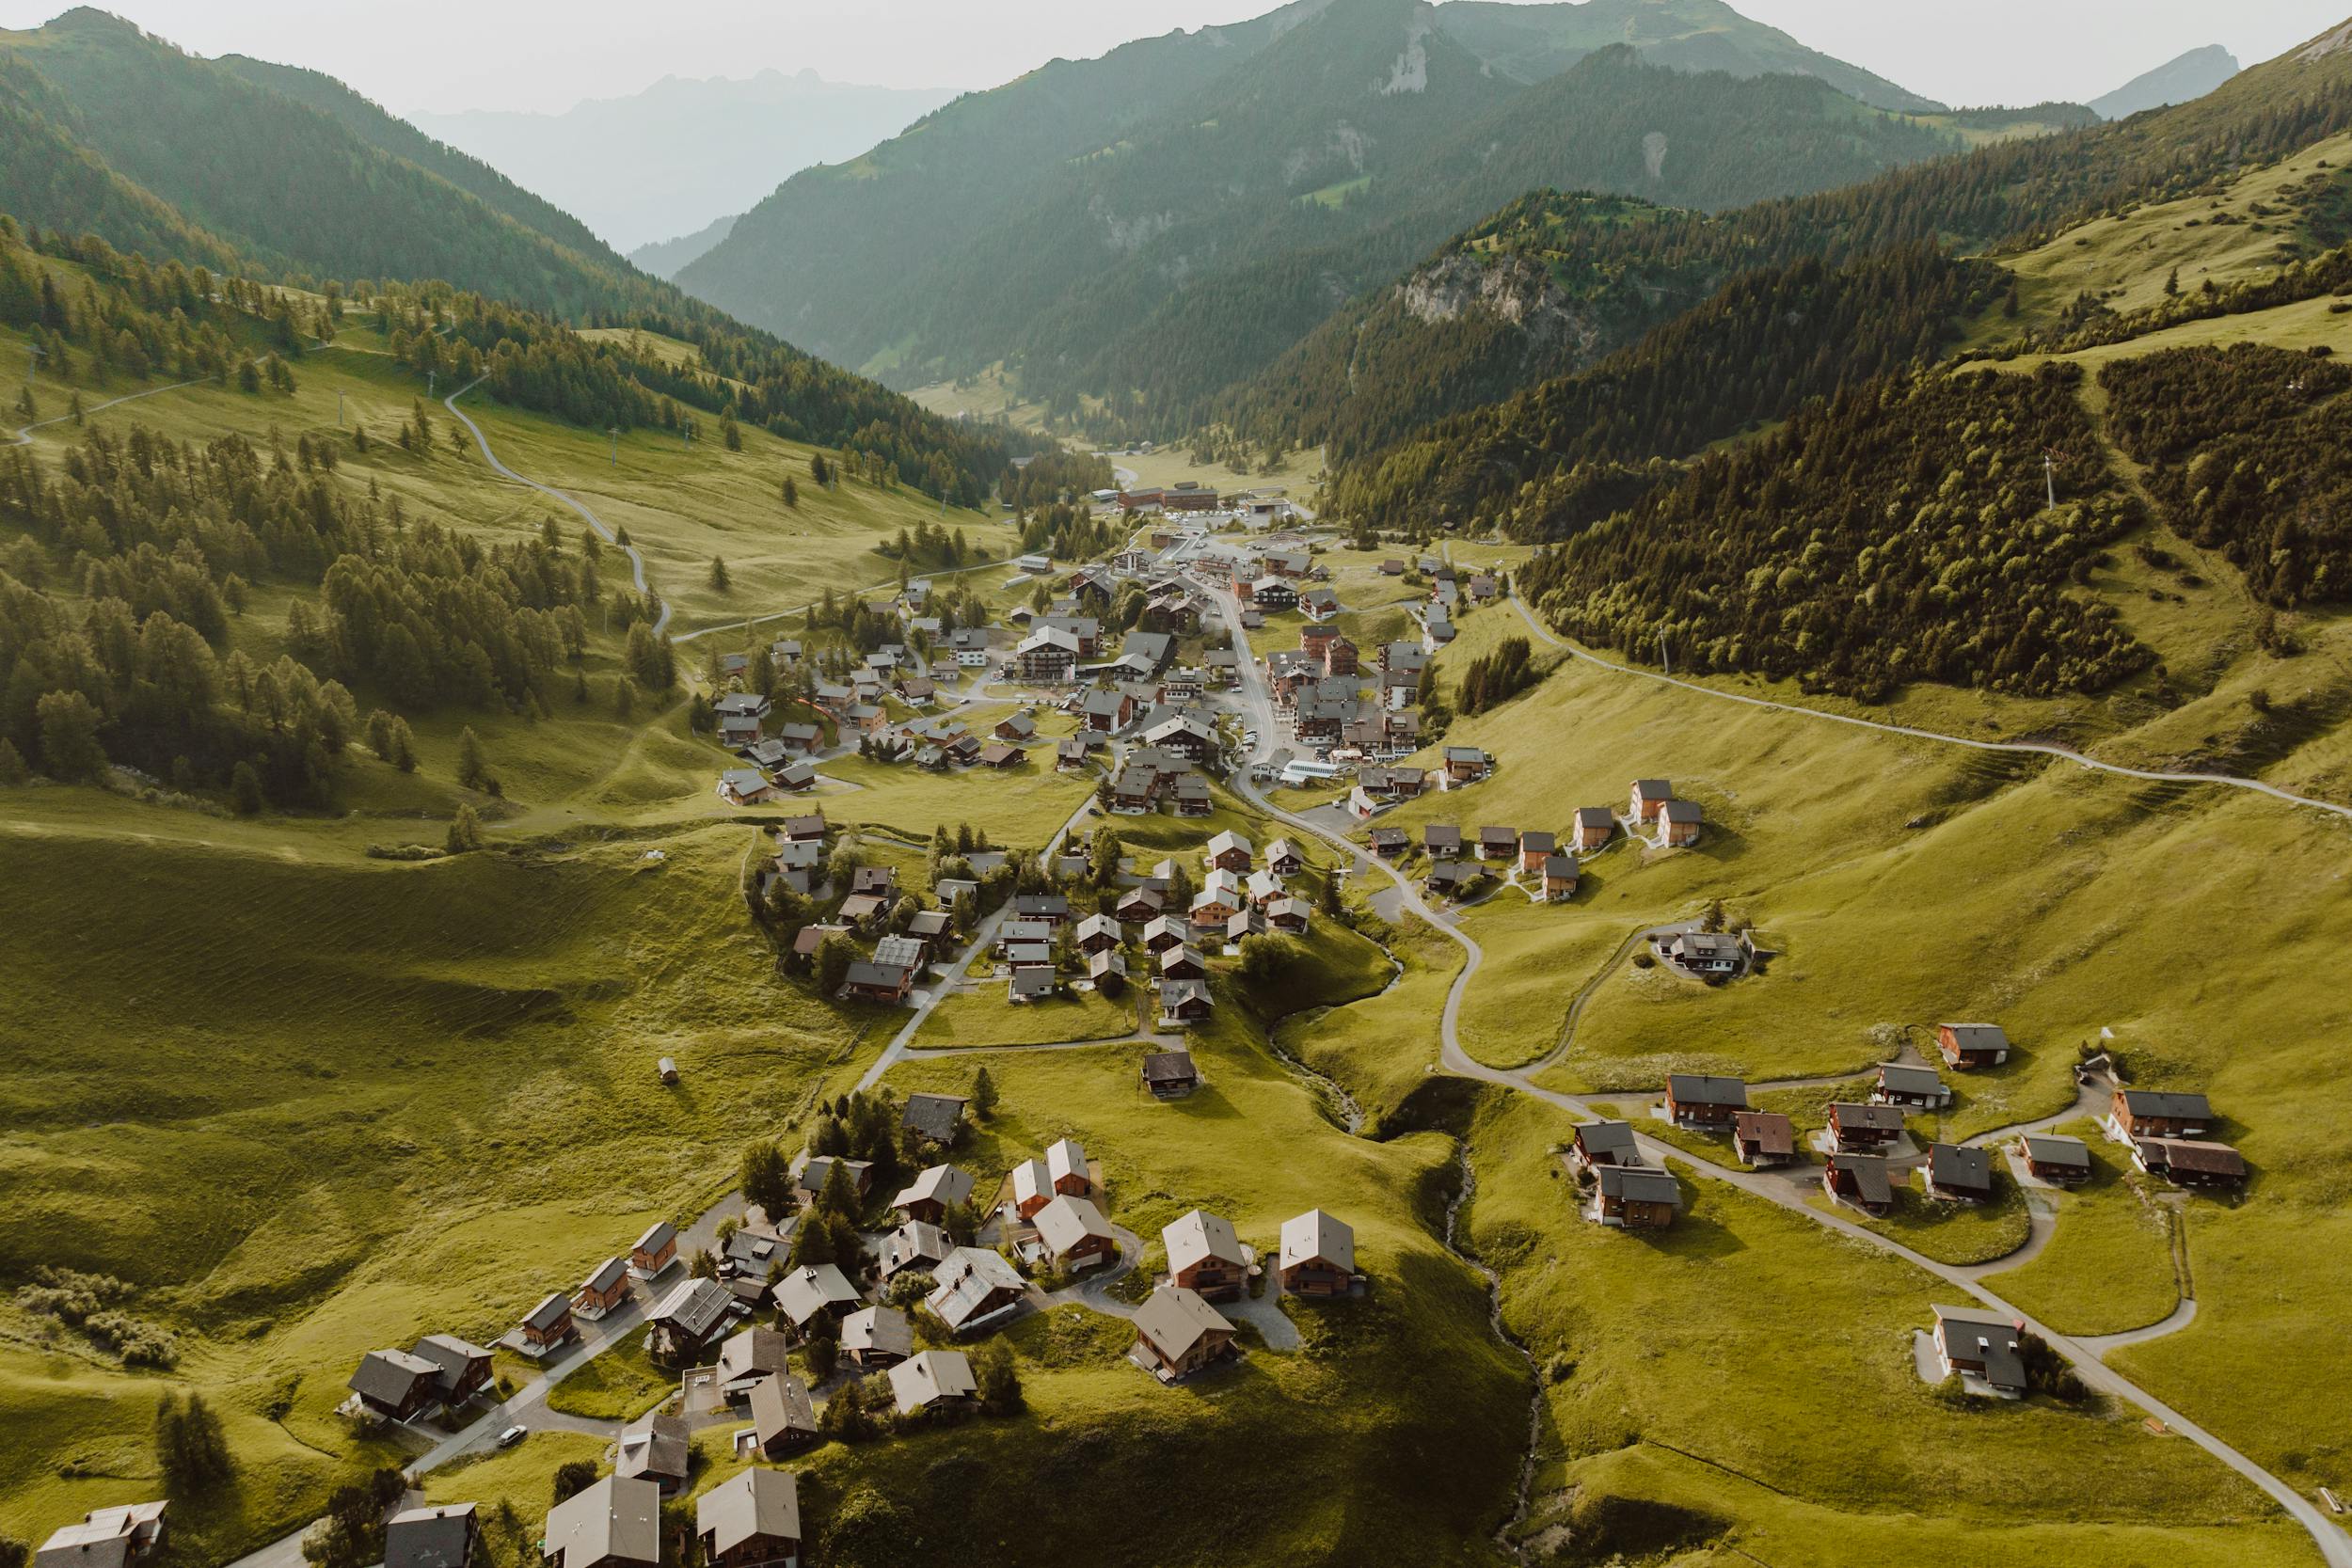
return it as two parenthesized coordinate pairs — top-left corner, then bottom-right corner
(0, 0), (2352, 110)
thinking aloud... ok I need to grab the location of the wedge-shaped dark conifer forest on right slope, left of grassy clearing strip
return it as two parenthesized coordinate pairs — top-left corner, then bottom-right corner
(1519, 367), (2153, 701)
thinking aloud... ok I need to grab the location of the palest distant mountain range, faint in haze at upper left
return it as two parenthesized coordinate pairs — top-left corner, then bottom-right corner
(412, 71), (955, 249)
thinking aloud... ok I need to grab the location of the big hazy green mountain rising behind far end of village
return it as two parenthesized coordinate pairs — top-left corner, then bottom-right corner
(680, 0), (1960, 416)
